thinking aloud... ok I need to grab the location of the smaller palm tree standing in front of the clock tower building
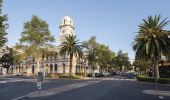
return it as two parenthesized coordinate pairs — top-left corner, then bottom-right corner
(60, 35), (83, 76)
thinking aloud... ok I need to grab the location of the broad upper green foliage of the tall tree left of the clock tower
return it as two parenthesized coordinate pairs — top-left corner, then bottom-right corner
(20, 16), (54, 47)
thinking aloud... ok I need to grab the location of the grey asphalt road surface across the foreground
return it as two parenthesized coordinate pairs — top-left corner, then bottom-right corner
(0, 76), (170, 100)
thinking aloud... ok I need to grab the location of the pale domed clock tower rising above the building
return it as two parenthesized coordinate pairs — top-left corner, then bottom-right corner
(60, 16), (74, 43)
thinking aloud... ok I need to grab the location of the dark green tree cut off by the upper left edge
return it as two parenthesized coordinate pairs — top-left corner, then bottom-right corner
(0, 0), (9, 48)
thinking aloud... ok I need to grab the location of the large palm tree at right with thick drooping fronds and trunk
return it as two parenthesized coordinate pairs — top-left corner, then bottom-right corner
(132, 15), (170, 78)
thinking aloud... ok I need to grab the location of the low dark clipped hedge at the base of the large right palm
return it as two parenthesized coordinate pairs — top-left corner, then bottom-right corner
(137, 77), (170, 84)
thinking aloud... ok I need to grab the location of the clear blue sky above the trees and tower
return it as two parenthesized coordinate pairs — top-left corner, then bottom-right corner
(3, 0), (170, 60)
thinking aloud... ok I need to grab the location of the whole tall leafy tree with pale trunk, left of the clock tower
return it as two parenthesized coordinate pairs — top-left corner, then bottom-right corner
(20, 16), (55, 71)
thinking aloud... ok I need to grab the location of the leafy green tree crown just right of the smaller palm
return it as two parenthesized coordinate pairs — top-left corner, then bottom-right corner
(83, 36), (115, 71)
